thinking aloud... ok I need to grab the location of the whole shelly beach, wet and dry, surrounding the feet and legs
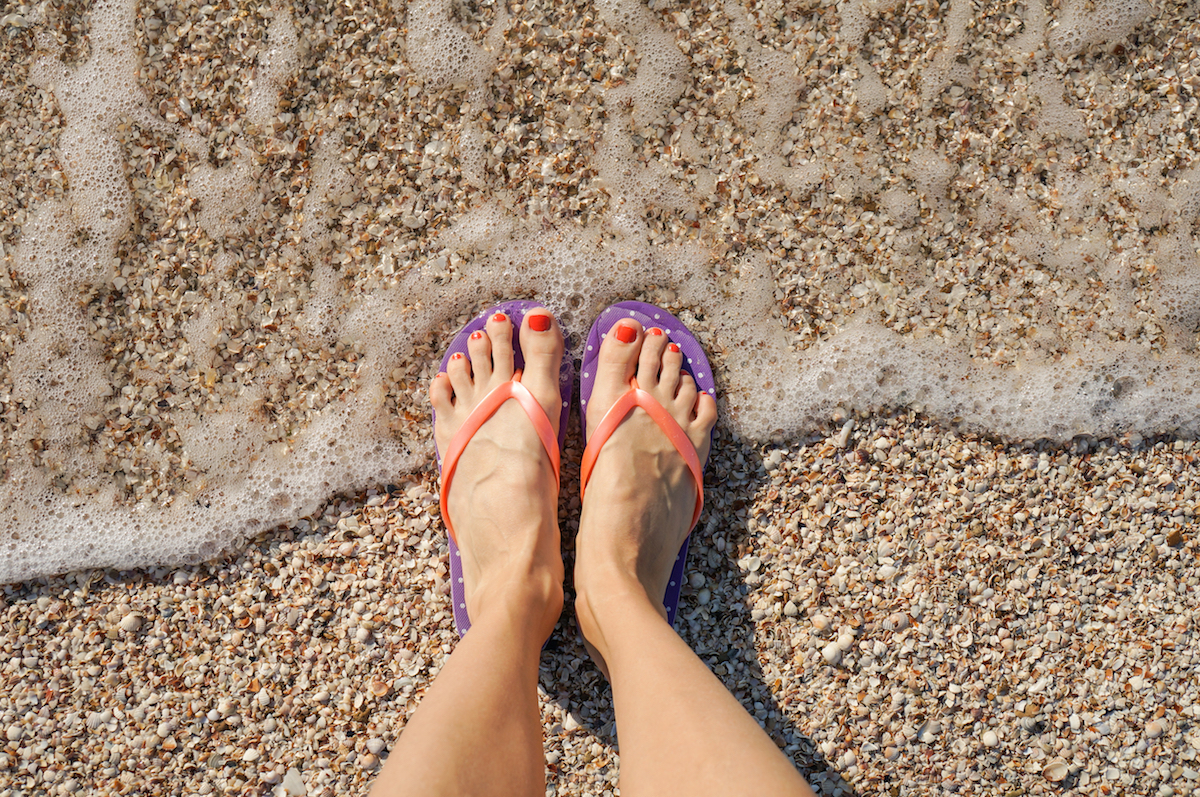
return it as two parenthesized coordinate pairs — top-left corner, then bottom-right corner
(0, 0), (1200, 797)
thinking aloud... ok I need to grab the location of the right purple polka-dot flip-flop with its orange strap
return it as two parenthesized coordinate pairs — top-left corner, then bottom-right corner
(580, 301), (716, 627)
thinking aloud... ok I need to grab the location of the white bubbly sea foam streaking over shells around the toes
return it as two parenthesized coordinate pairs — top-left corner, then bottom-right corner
(0, 0), (1200, 581)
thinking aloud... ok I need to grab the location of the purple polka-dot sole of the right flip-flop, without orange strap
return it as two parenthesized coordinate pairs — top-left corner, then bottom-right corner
(580, 301), (716, 627)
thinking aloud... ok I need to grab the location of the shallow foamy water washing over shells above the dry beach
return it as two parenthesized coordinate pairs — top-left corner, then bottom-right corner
(0, 0), (1200, 581)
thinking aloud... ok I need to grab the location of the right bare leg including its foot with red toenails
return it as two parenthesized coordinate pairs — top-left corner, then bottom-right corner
(575, 319), (812, 797)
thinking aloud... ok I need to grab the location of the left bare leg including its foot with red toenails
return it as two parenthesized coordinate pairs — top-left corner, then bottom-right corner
(372, 311), (563, 797)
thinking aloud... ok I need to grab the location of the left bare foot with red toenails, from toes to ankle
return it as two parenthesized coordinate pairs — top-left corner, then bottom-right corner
(430, 308), (563, 639)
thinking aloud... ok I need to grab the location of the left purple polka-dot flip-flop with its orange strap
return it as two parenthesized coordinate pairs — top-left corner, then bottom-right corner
(433, 301), (575, 636)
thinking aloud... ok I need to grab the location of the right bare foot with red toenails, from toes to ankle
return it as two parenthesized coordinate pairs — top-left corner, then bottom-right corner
(575, 318), (716, 675)
